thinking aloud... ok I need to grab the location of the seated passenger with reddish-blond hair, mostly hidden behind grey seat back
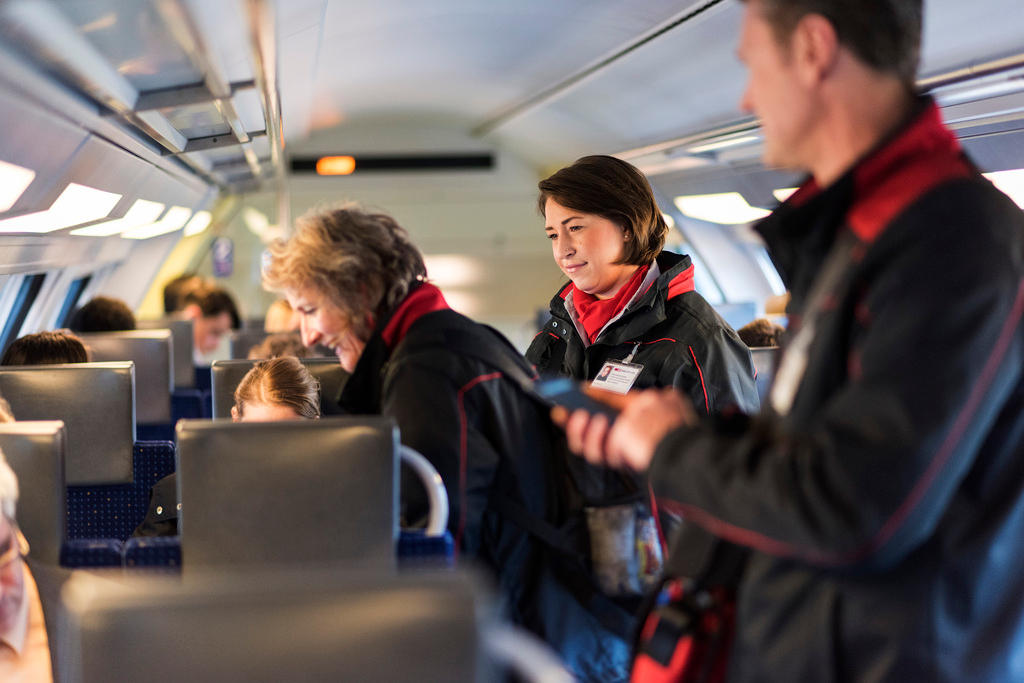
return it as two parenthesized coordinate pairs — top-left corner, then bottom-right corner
(132, 356), (319, 537)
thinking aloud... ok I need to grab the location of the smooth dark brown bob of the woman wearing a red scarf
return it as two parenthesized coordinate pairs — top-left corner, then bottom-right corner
(537, 155), (669, 265)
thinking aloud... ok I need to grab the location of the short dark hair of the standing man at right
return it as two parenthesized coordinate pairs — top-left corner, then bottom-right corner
(743, 0), (924, 90)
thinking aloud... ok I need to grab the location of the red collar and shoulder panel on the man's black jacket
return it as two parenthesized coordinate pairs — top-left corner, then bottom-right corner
(847, 102), (972, 243)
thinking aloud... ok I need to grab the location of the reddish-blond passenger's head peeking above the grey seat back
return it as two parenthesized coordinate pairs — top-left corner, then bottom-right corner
(231, 356), (319, 422)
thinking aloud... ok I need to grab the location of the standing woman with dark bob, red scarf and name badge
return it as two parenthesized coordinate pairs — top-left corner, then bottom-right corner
(526, 156), (759, 415)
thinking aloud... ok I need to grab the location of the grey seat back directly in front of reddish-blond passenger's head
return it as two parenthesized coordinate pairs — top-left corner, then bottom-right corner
(177, 418), (398, 571)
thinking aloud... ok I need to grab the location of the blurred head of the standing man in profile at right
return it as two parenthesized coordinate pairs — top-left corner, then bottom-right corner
(737, 0), (923, 171)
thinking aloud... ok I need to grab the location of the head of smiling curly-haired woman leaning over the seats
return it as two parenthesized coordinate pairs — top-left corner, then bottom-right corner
(263, 204), (427, 372)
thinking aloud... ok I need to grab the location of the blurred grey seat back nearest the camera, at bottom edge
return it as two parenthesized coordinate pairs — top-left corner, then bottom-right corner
(62, 569), (489, 683)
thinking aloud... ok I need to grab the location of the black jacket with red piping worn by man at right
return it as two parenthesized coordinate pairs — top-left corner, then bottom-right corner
(649, 99), (1024, 682)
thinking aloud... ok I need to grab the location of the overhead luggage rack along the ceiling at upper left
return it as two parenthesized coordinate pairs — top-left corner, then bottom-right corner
(0, 0), (284, 191)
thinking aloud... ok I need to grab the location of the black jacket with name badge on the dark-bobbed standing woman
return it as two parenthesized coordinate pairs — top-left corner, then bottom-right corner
(526, 251), (758, 414)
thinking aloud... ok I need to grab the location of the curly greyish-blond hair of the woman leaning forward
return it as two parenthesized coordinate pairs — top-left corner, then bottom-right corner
(263, 204), (427, 340)
